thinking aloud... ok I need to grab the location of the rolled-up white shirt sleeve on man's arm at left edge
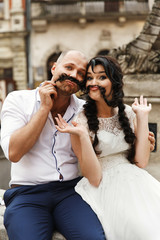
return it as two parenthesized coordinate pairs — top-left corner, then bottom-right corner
(1, 92), (26, 159)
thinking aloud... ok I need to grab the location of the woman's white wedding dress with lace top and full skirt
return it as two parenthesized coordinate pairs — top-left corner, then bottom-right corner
(75, 105), (160, 240)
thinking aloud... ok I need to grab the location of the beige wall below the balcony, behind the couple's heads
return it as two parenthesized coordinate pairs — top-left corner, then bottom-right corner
(31, 19), (144, 82)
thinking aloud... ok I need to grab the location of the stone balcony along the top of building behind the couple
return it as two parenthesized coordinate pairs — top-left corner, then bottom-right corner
(32, 0), (149, 21)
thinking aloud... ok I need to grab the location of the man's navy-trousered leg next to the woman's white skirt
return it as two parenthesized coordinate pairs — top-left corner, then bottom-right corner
(54, 192), (106, 240)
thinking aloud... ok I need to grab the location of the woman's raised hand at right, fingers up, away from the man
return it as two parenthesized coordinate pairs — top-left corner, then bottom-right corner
(132, 95), (152, 114)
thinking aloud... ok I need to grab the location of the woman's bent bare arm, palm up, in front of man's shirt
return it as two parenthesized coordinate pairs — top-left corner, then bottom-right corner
(56, 115), (102, 187)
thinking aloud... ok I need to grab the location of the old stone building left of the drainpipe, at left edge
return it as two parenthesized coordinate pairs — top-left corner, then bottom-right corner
(0, 0), (27, 101)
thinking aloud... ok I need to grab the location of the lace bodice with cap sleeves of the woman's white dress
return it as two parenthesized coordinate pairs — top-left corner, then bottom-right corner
(75, 105), (135, 158)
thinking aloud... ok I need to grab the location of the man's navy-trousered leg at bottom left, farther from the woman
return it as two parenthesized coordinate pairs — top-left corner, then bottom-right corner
(4, 187), (53, 240)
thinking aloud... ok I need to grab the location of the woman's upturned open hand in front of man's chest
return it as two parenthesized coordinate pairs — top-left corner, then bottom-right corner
(55, 114), (88, 136)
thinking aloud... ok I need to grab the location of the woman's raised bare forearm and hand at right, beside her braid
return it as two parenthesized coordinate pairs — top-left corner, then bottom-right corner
(132, 96), (151, 168)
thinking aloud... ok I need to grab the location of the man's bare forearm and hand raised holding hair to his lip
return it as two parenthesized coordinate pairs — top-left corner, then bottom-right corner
(2, 81), (57, 162)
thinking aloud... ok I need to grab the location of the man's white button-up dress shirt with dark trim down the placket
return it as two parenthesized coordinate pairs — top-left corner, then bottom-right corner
(1, 88), (84, 185)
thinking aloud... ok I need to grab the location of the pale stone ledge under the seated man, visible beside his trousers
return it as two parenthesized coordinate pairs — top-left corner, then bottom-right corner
(0, 189), (66, 240)
